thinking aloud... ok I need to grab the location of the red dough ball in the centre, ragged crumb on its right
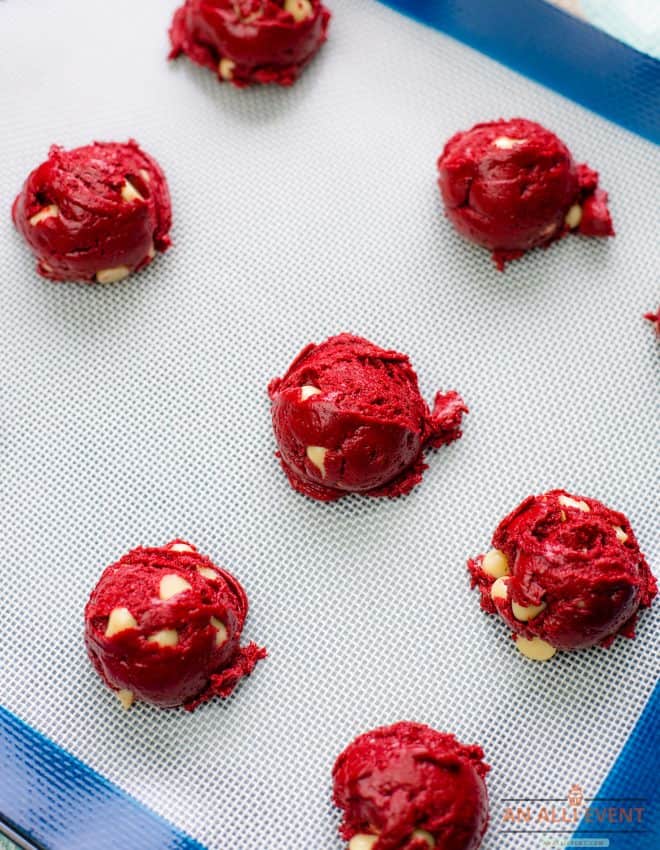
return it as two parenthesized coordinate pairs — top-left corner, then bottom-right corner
(268, 334), (467, 501)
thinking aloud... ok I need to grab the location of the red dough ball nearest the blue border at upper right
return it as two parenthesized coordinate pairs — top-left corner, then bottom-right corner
(438, 118), (614, 270)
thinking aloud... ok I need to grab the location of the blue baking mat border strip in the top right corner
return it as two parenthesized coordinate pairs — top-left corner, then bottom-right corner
(378, 0), (660, 144)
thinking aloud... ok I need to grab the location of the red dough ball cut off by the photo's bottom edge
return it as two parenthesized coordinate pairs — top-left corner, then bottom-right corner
(332, 722), (490, 850)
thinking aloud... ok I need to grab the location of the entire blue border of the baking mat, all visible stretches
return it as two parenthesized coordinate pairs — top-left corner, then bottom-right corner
(0, 0), (660, 850)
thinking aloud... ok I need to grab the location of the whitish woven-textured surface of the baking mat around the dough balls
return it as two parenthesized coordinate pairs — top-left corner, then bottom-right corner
(0, 0), (660, 850)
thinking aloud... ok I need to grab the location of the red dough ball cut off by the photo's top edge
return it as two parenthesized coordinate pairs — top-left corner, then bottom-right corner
(170, 0), (330, 88)
